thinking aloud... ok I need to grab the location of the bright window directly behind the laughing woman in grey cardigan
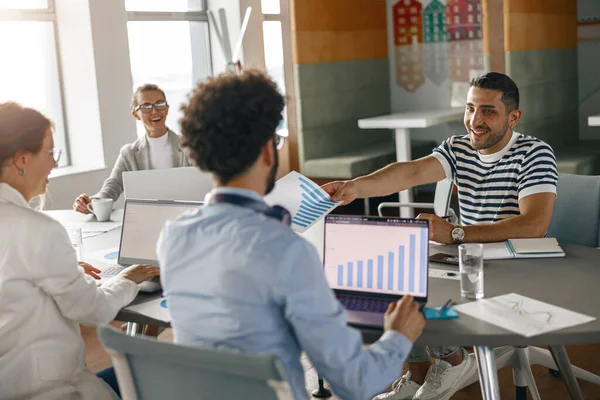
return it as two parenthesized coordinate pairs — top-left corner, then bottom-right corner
(125, 0), (212, 137)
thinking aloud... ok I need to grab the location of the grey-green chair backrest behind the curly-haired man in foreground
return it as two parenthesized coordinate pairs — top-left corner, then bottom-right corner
(98, 326), (293, 400)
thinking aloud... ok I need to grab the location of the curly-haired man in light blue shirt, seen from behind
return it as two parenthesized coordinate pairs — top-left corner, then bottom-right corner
(157, 71), (425, 400)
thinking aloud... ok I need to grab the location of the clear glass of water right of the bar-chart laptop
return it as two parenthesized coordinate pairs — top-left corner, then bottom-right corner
(458, 243), (483, 300)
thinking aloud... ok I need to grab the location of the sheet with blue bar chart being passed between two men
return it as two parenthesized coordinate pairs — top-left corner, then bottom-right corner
(265, 171), (339, 233)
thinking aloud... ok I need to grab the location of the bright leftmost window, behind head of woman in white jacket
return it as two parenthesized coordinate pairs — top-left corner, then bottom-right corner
(0, 0), (69, 167)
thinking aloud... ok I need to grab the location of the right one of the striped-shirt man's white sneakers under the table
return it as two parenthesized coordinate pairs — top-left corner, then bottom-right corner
(414, 349), (477, 400)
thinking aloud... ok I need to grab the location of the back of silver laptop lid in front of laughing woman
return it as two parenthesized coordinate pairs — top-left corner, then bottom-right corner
(123, 167), (213, 201)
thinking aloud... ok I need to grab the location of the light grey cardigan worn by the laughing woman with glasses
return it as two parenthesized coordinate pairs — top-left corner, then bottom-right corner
(91, 129), (191, 201)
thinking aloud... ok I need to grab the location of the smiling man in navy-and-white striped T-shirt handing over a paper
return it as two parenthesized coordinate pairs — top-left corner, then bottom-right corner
(323, 72), (558, 400)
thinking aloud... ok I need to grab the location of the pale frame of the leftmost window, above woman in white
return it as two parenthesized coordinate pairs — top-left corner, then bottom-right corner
(0, 0), (71, 168)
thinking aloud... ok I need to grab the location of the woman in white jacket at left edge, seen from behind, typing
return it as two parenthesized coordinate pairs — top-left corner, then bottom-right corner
(0, 103), (158, 399)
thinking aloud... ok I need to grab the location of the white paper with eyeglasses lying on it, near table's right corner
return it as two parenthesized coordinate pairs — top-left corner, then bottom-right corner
(454, 293), (596, 337)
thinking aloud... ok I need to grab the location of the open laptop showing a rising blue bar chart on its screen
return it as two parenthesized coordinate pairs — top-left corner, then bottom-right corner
(323, 215), (429, 328)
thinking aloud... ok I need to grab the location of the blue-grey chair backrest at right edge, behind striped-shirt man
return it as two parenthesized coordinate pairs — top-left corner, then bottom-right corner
(547, 174), (600, 247)
